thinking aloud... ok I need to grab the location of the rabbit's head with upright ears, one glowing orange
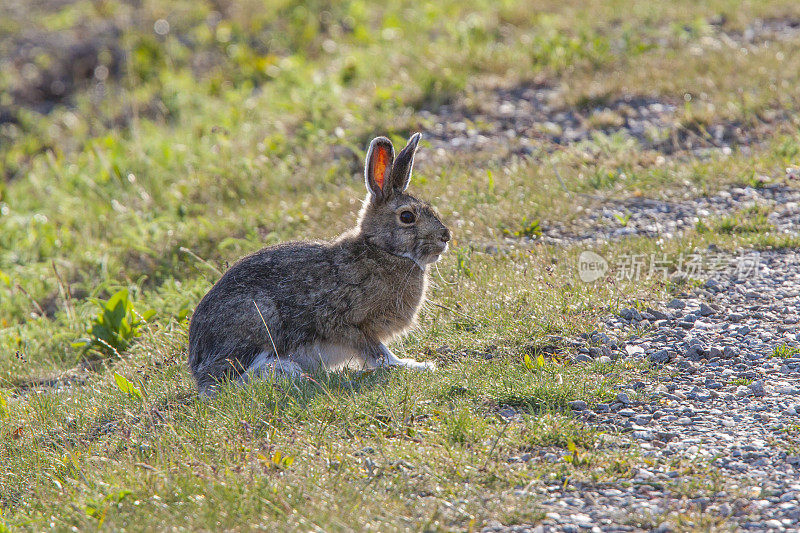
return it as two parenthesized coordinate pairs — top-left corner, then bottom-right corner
(359, 133), (450, 270)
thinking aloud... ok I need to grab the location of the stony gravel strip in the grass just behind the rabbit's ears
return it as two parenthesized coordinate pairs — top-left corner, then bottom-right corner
(419, 81), (777, 160)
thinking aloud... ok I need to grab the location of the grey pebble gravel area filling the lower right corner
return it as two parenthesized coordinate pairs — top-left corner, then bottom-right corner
(484, 251), (800, 532)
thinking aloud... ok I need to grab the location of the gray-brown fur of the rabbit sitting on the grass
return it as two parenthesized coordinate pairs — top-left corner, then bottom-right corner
(189, 134), (450, 394)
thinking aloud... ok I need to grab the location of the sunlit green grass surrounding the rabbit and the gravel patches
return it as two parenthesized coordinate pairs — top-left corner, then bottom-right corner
(0, 0), (800, 531)
